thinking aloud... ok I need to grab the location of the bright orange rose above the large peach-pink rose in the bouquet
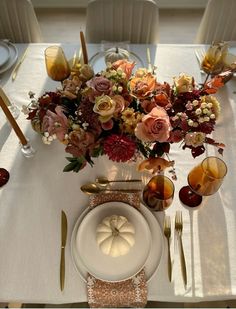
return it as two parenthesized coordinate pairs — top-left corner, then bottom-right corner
(129, 73), (157, 99)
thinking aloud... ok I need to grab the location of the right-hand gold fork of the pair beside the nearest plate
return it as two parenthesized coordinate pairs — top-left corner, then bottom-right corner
(175, 211), (187, 286)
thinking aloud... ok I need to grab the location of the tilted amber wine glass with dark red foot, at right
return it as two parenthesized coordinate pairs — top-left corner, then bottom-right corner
(179, 157), (227, 207)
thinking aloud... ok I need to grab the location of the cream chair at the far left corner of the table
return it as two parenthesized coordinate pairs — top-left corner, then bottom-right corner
(0, 0), (42, 43)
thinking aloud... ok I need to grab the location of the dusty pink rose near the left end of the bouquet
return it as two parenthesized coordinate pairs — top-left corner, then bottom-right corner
(42, 106), (68, 142)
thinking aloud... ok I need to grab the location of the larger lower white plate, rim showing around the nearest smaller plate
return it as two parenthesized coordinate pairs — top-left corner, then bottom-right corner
(71, 204), (163, 282)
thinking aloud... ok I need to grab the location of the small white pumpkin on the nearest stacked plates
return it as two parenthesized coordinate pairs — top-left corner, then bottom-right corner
(96, 215), (135, 257)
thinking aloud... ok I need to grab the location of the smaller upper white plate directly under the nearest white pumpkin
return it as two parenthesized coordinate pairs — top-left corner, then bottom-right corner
(75, 202), (151, 282)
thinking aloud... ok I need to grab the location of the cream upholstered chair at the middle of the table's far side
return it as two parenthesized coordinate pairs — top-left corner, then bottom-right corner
(86, 0), (159, 43)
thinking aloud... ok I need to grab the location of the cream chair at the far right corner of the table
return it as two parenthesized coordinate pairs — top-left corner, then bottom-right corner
(194, 0), (236, 44)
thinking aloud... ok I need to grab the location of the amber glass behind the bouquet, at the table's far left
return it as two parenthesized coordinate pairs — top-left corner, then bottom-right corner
(44, 46), (70, 82)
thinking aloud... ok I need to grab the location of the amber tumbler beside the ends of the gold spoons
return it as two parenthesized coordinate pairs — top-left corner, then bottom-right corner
(143, 175), (175, 211)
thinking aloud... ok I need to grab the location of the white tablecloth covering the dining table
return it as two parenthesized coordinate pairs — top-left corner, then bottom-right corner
(0, 42), (236, 304)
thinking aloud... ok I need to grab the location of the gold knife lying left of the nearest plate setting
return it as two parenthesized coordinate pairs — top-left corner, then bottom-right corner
(60, 210), (67, 291)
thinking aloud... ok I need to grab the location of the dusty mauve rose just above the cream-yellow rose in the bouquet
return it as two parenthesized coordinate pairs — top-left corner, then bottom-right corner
(86, 76), (112, 96)
